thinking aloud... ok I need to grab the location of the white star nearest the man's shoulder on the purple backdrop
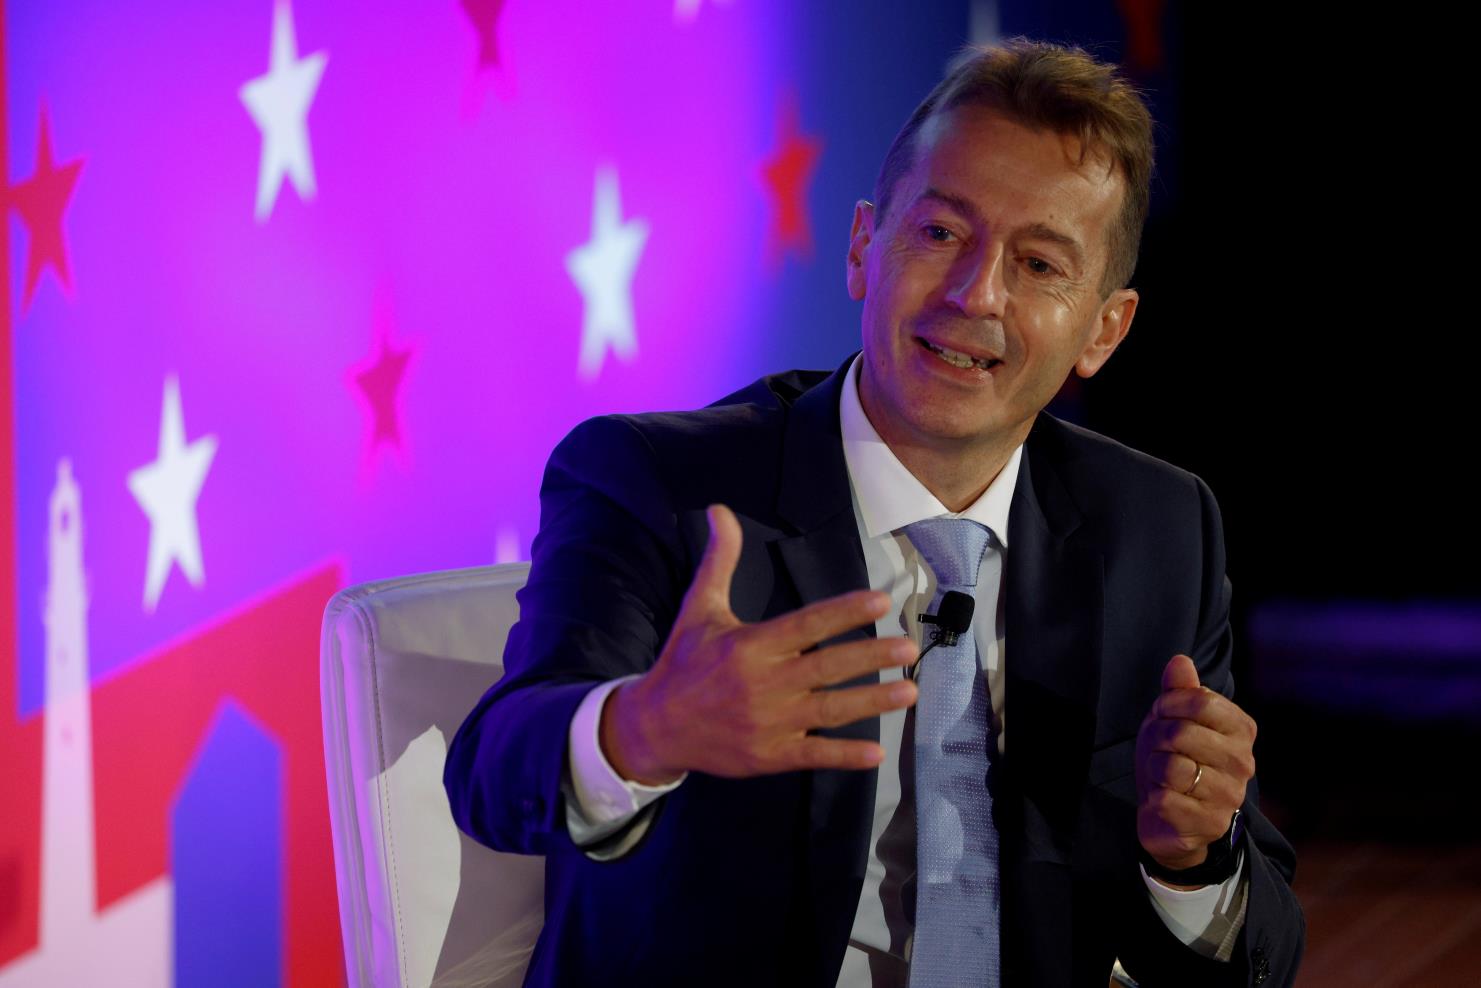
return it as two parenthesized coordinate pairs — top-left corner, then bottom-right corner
(566, 167), (647, 381)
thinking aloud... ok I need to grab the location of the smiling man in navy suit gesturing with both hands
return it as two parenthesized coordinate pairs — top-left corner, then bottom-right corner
(446, 41), (1303, 988)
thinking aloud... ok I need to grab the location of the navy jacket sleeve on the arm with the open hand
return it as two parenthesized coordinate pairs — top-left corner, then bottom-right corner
(443, 416), (692, 856)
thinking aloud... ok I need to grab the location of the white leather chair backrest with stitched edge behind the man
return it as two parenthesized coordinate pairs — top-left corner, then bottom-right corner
(320, 563), (545, 988)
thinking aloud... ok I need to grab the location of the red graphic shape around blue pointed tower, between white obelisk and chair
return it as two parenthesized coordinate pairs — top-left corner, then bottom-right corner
(92, 564), (344, 988)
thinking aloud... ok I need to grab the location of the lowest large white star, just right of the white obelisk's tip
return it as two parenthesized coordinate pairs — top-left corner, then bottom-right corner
(129, 375), (216, 613)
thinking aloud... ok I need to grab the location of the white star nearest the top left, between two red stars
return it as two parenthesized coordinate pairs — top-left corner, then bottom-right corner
(241, 0), (329, 224)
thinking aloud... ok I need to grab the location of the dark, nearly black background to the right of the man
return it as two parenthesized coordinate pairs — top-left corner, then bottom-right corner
(1003, 3), (1481, 985)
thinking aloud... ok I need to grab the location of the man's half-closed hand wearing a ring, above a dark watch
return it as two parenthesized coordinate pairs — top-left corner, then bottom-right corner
(1136, 655), (1254, 869)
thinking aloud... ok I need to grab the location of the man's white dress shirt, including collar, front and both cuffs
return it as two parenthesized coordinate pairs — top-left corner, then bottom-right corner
(566, 358), (1246, 988)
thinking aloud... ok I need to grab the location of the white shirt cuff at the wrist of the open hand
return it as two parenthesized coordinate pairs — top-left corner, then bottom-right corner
(566, 675), (689, 844)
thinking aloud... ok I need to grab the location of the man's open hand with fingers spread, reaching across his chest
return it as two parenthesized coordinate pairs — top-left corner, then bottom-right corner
(600, 505), (918, 782)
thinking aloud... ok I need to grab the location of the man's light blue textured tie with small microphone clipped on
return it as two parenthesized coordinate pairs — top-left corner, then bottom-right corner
(905, 518), (1001, 988)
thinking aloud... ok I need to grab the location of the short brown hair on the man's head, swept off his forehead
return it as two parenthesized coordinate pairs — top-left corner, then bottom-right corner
(874, 37), (1152, 295)
